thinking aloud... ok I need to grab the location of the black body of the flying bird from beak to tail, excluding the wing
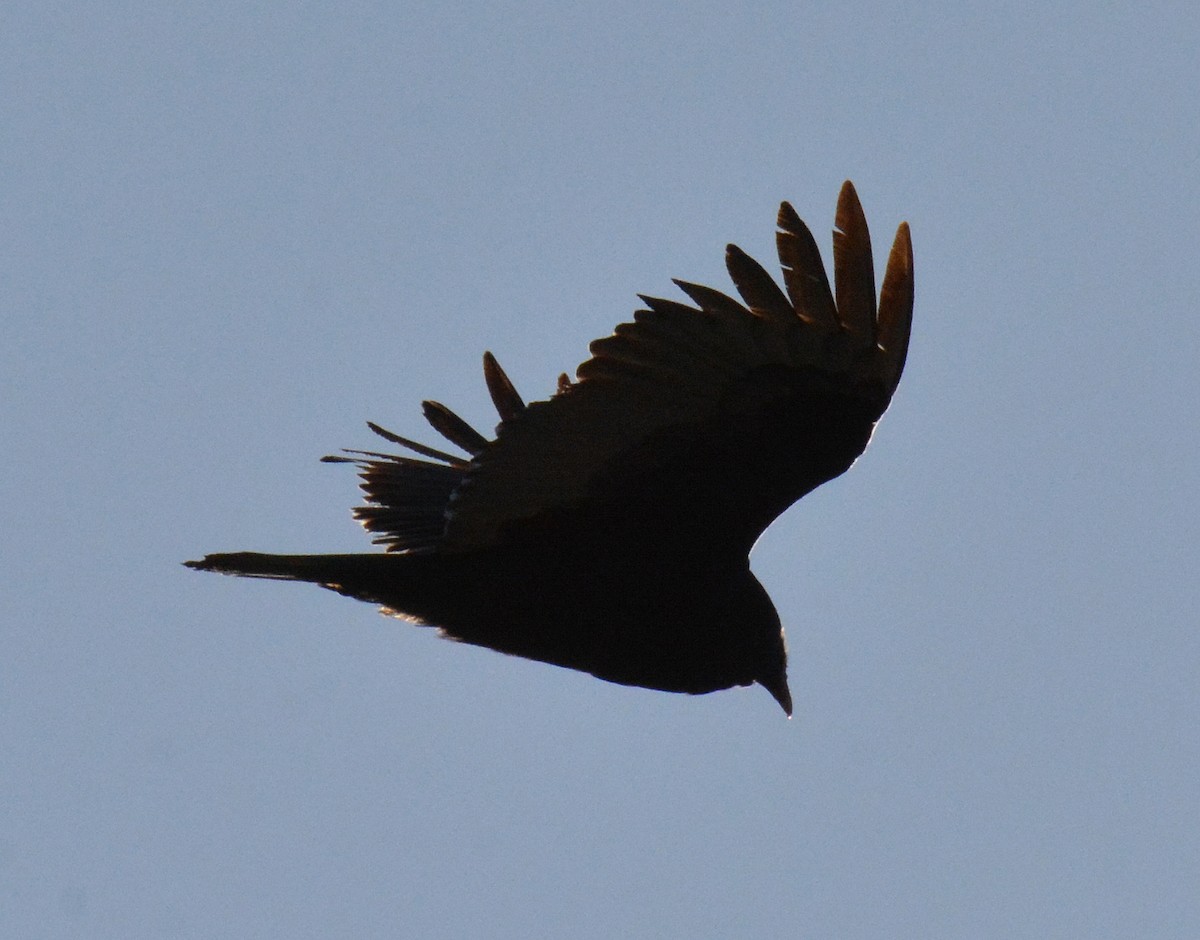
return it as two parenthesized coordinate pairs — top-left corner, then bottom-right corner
(205, 528), (791, 708)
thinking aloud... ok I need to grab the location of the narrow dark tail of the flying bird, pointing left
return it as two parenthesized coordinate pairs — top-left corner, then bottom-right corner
(184, 551), (415, 606)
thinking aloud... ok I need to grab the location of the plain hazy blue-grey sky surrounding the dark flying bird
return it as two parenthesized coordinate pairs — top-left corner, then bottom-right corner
(0, 0), (1200, 938)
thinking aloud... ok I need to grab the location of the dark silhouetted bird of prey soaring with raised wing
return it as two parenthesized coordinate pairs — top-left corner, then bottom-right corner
(185, 180), (913, 717)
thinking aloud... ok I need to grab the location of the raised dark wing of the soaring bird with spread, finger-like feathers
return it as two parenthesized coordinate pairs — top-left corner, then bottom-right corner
(328, 181), (913, 551)
